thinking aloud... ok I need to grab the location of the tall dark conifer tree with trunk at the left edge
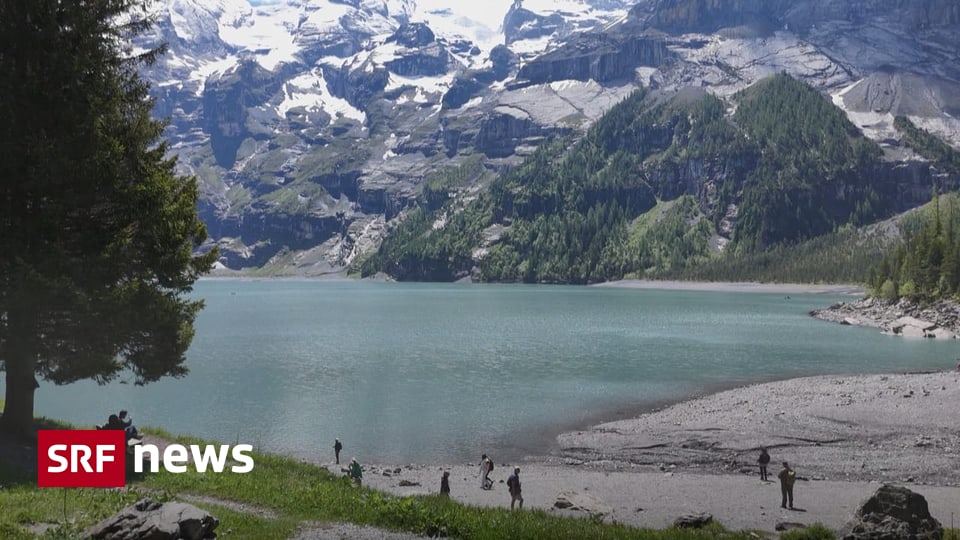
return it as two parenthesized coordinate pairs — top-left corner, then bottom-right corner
(0, 0), (216, 435)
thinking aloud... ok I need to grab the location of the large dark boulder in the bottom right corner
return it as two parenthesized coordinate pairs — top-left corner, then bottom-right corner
(840, 484), (943, 540)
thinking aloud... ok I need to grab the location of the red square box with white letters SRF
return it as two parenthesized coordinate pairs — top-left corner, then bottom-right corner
(37, 430), (127, 488)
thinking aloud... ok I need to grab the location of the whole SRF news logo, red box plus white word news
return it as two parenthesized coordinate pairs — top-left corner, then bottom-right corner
(37, 430), (253, 488)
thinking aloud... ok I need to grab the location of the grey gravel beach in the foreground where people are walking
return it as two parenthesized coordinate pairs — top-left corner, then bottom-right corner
(324, 371), (960, 531)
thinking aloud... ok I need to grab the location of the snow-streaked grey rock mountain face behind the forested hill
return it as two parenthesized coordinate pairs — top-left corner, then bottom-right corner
(142, 0), (960, 275)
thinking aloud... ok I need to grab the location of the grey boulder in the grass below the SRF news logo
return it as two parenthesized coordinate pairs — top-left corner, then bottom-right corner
(83, 499), (220, 540)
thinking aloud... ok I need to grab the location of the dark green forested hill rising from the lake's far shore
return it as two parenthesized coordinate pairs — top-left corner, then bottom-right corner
(361, 74), (940, 283)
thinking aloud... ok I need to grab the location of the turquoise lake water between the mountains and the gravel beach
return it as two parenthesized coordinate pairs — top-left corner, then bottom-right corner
(9, 280), (957, 464)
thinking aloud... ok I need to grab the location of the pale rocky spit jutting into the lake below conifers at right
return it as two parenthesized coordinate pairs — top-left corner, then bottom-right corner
(810, 297), (960, 339)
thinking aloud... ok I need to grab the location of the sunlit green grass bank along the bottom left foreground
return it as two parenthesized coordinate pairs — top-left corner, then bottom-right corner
(0, 424), (764, 540)
